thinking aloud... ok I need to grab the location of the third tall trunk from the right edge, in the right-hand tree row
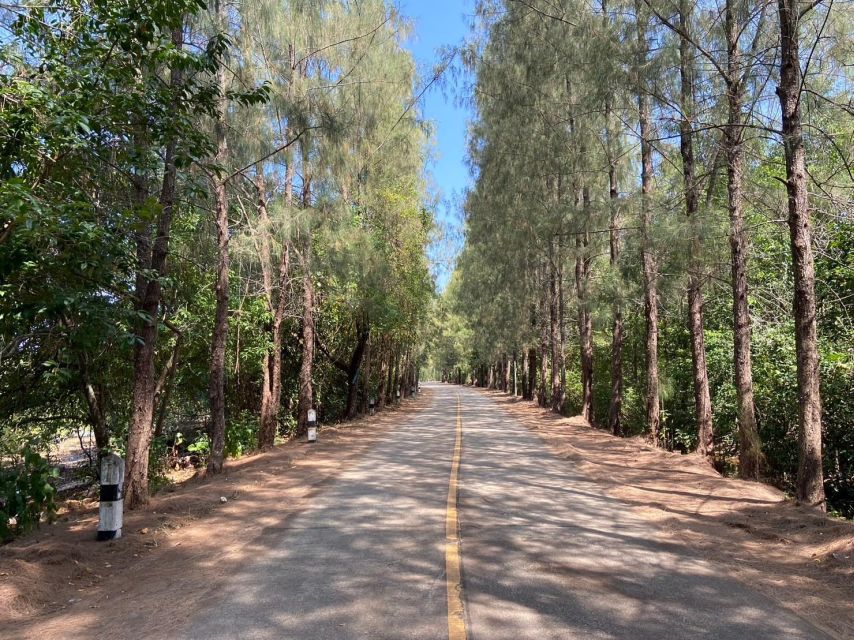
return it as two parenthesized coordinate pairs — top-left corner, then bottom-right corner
(679, 0), (714, 459)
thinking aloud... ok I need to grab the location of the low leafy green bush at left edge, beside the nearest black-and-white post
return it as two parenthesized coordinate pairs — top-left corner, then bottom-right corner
(0, 445), (59, 542)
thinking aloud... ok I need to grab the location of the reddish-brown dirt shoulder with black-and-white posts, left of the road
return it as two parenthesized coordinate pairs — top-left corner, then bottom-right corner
(0, 390), (430, 640)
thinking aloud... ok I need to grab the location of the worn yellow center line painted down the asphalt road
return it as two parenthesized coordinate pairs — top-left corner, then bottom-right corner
(445, 394), (467, 640)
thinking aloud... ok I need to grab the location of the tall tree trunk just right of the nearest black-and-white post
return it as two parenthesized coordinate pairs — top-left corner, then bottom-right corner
(124, 27), (184, 509)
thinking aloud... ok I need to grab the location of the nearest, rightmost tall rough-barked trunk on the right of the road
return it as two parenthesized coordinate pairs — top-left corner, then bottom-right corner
(777, 0), (827, 510)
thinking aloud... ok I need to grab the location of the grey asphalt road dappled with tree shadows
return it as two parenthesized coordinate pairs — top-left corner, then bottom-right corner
(184, 385), (827, 640)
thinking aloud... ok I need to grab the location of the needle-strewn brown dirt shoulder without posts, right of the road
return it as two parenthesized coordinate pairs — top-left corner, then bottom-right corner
(481, 390), (854, 639)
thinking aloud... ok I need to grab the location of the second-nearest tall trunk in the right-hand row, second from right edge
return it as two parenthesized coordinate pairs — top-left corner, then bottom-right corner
(724, 0), (762, 479)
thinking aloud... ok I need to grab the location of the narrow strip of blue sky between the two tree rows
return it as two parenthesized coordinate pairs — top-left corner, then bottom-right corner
(399, 0), (473, 289)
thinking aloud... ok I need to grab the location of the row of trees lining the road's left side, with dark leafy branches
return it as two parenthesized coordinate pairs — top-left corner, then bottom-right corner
(0, 0), (433, 534)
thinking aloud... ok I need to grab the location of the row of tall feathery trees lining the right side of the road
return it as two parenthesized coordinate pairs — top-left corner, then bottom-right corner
(431, 0), (854, 517)
